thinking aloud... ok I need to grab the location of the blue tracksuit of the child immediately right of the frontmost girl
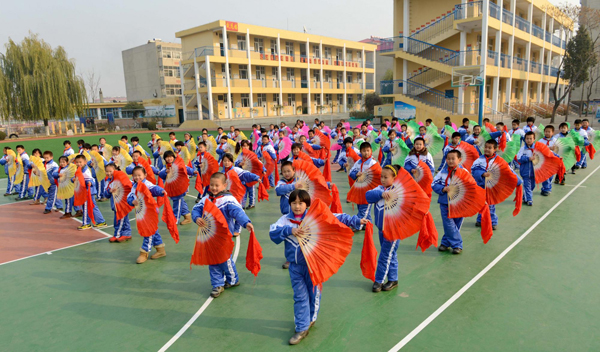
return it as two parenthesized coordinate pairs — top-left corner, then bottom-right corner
(366, 186), (400, 284)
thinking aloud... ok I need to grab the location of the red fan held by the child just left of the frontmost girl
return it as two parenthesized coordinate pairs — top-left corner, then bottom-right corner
(190, 199), (234, 267)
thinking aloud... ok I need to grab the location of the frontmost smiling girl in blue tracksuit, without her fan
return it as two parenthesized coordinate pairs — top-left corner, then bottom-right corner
(269, 189), (367, 345)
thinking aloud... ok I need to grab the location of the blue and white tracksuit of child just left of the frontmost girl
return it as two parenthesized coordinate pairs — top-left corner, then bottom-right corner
(192, 192), (250, 288)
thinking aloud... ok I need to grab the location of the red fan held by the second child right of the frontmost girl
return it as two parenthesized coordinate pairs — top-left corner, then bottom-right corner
(448, 168), (485, 219)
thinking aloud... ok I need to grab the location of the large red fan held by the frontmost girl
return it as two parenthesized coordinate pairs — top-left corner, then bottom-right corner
(296, 199), (354, 286)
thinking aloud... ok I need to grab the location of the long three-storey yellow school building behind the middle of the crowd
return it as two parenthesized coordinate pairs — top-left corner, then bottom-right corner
(176, 20), (376, 120)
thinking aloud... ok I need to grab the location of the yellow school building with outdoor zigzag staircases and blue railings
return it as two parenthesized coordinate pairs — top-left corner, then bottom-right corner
(379, 0), (573, 119)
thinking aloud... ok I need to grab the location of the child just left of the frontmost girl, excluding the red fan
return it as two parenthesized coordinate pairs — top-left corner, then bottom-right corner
(192, 172), (254, 298)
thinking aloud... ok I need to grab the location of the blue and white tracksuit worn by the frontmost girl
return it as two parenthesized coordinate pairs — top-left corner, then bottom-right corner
(269, 212), (360, 332)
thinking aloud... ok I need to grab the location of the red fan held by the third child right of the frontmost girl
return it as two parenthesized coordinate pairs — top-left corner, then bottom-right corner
(485, 157), (519, 205)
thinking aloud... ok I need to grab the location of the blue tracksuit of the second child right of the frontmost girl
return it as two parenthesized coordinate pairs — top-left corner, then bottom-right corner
(431, 165), (464, 249)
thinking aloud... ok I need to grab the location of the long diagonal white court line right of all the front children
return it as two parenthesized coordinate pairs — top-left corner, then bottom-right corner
(390, 166), (600, 352)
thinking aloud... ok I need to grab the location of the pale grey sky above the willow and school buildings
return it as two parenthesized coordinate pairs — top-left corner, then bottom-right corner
(0, 0), (579, 97)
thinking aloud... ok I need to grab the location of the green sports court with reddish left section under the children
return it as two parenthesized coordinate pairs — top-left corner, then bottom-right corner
(0, 132), (600, 351)
